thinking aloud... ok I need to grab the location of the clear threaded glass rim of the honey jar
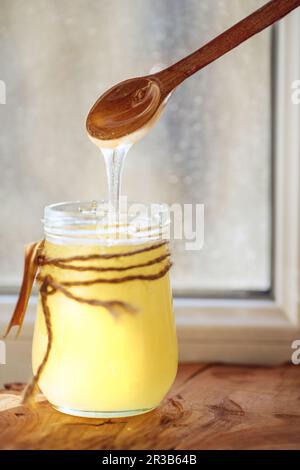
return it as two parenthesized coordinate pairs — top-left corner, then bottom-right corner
(42, 198), (170, 245)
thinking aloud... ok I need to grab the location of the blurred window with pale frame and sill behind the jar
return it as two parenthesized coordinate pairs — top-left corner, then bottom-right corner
(0, 0), (300, 370)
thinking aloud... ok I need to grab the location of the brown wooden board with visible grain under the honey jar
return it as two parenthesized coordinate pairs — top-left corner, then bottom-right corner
(0, 364), (300, 450)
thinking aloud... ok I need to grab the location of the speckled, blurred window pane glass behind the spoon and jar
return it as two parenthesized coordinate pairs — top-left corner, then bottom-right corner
(0, 0), (272, 294)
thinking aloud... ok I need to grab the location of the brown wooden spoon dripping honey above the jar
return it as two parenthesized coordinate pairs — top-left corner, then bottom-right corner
(86, 0), (300, 147)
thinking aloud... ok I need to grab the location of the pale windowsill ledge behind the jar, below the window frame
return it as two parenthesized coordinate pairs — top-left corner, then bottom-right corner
(0, 295), (300, 387)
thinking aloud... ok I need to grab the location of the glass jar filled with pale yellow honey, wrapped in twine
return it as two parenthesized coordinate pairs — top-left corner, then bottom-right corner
(33, 202), (177, 417)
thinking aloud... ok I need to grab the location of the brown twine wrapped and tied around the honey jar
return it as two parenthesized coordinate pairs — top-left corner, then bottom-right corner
(6, 241), (172, 404)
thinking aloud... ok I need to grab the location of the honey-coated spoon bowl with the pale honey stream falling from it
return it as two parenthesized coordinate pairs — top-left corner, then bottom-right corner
(87, 78), (166, 225)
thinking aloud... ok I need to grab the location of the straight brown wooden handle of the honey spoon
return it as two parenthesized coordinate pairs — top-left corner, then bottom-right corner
(154, 0), (300, 94)
